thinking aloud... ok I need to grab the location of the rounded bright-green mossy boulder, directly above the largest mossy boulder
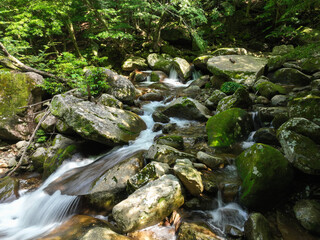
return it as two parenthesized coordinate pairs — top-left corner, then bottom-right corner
(206, 108), (252, 147)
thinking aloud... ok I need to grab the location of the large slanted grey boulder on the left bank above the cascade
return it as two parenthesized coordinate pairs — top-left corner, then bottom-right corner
(51, 95), (146, 146)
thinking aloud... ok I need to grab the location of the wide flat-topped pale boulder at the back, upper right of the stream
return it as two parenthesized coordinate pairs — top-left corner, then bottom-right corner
(207, 55), (267, 85)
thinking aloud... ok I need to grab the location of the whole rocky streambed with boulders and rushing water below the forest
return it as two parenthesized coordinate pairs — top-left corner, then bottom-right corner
(0, 46), (320, 240)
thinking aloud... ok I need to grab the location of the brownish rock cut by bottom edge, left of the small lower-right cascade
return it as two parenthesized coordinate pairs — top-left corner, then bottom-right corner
(178, 222), (222, 240)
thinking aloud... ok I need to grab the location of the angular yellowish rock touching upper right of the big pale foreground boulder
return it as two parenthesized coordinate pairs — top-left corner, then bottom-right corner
(173, 159), (203, 196)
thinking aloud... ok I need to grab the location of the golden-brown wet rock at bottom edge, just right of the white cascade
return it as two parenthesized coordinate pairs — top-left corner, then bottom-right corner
(39, 215), (129, 240)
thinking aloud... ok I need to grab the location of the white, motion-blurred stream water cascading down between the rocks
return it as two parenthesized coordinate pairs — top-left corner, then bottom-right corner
(0, 71), (246, 240)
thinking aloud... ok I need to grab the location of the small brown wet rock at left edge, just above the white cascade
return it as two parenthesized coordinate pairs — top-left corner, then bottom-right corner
(0, 177), (20, 203)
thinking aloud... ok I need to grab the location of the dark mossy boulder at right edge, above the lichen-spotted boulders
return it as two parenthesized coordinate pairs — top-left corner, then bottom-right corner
(288, 95), (320, 125)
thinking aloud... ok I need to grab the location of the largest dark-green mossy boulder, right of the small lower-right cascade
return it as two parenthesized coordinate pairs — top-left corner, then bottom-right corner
(236, 143), (293, 209)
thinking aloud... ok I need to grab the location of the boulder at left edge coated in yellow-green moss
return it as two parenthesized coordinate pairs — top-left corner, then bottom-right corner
(0, 71), (43, 141)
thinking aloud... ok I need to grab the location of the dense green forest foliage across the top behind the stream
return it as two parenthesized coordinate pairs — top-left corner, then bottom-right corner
(0, 0), (320, 94)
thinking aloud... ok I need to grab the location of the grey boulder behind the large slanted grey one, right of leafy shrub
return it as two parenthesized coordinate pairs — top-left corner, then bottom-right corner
(103, 69), (136, 102)
